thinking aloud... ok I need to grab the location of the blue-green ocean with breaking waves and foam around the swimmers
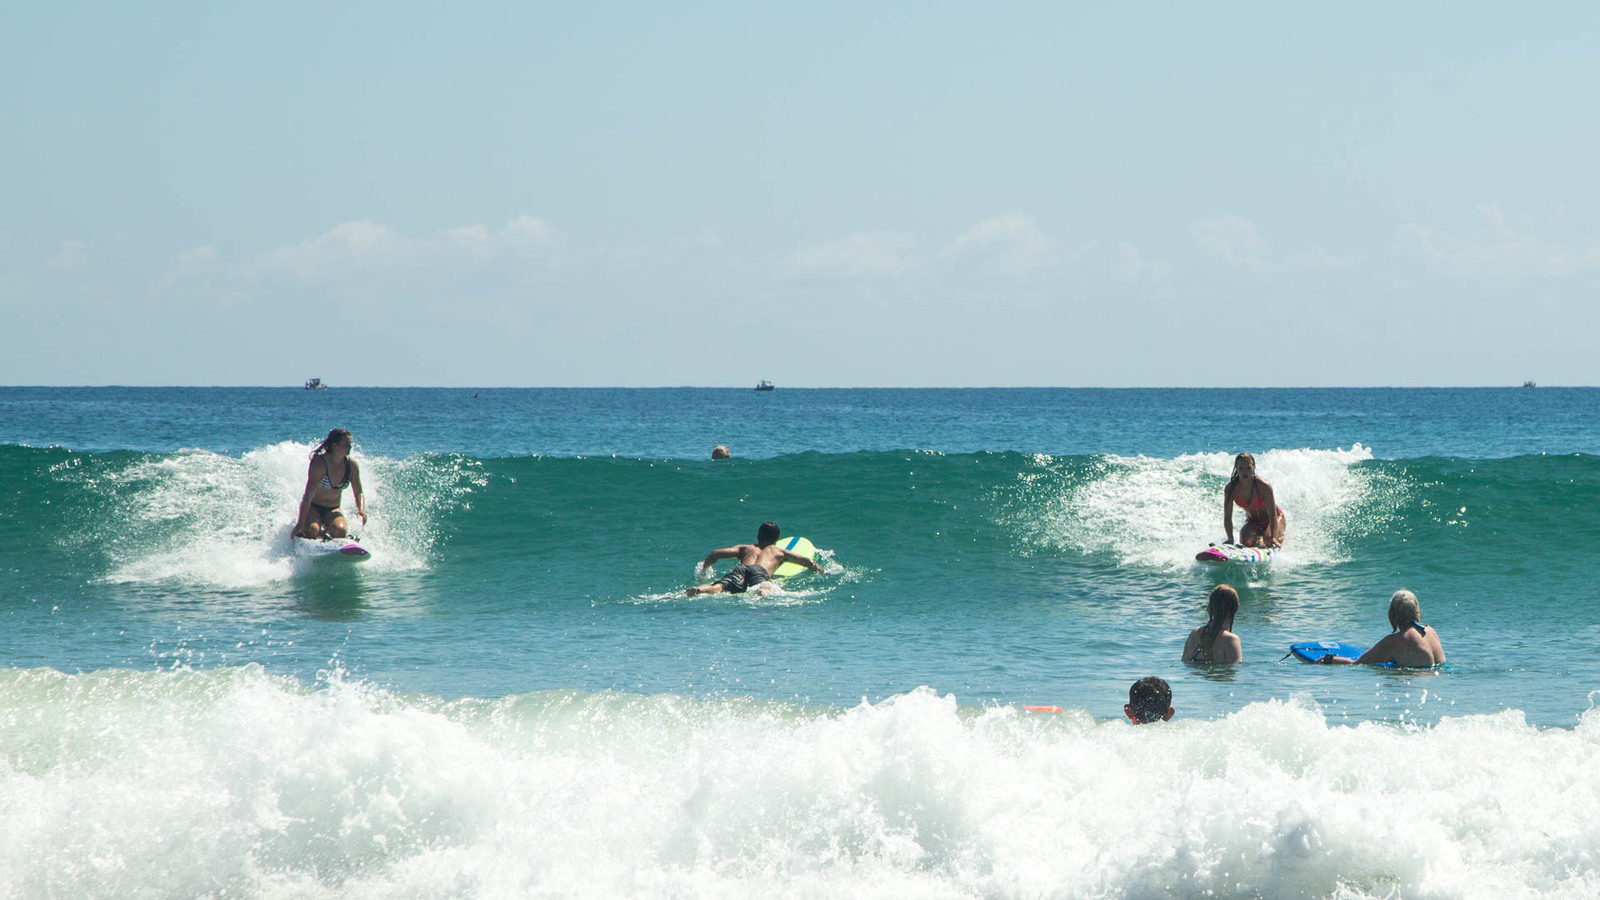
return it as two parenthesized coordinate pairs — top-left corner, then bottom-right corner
(0, 388), (1600, 900)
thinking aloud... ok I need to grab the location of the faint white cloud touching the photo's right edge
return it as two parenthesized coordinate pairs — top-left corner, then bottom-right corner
(1395, 203), (1600, 277)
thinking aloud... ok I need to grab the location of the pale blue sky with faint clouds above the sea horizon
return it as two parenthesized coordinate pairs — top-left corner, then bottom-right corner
(0, 0), (1600, 388)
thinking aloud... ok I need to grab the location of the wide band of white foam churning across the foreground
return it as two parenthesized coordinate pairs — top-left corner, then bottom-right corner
(0, 666), (1600, 898)
